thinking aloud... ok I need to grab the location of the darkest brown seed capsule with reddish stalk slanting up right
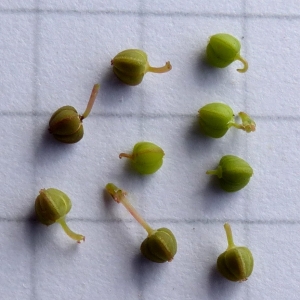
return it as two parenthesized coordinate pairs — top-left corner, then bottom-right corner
(49, 84), (100, 144)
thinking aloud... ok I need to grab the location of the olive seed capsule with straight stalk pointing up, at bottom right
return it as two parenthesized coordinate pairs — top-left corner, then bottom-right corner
(217, 223), (254, 282)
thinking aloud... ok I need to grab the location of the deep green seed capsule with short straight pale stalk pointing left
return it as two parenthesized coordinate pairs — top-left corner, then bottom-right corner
(206, 155), (253, 192)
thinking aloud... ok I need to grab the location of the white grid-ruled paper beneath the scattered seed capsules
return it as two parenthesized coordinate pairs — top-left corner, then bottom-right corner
(0, 0), (300, 300)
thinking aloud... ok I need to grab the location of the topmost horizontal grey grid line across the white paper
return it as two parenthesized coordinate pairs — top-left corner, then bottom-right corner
(0, 8), (300, 20)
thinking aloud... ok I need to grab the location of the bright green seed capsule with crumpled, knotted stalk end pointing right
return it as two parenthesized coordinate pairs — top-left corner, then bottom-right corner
(198, 102), (256, 138)
